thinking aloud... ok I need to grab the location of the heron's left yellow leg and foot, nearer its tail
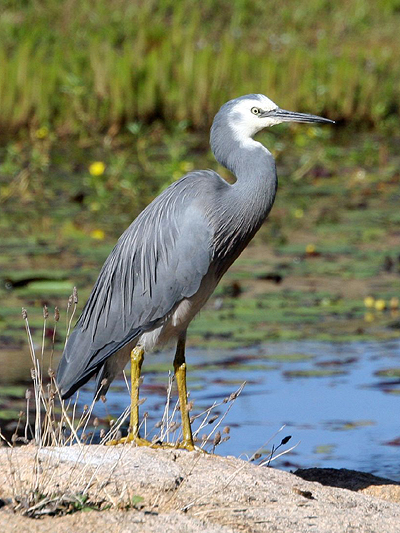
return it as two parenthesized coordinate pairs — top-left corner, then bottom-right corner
(107, 346), (151, 446)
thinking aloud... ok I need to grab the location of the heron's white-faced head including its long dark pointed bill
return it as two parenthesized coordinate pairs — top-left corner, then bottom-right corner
(214, 94), (333, 139)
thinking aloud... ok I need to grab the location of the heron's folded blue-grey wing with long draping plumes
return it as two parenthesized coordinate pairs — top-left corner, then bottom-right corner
(57, 171), (226, 397)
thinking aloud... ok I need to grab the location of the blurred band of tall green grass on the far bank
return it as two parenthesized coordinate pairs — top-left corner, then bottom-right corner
(0, 0), (400, 133)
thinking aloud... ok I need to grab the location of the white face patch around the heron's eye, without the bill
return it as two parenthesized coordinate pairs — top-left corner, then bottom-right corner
(229, 94), (280, 142)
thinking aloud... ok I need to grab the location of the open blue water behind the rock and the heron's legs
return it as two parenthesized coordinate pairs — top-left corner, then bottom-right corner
(77, 340), (400, 480)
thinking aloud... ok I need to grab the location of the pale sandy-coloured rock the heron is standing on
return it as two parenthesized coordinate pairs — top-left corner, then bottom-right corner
(0, 446), (400, 533)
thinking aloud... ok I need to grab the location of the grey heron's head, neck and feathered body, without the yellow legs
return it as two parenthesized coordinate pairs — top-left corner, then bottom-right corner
(57, 95), (329, 412)
